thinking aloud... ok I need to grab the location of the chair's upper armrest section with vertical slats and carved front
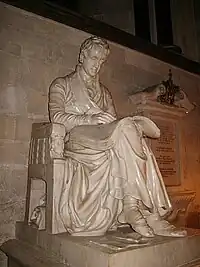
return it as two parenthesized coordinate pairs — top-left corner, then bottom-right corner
(29, 122), (65, 164)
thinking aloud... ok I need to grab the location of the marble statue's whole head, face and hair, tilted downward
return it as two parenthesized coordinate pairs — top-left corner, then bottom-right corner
(79, 36), (110, 77)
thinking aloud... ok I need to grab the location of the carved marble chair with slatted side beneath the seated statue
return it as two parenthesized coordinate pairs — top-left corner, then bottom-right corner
(25, 122), (66, 234)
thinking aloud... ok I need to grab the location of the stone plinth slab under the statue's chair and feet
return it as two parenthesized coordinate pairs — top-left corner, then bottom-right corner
(2, 223), (200, 267)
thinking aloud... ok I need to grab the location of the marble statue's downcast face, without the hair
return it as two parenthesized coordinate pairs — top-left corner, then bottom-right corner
(82, 45), (107, 77)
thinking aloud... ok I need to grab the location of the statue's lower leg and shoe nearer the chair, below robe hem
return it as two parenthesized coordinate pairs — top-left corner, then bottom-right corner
(123, 196), (154, 237)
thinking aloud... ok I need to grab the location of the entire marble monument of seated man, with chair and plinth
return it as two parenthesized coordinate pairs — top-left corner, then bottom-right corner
(1, 37), (200, 267)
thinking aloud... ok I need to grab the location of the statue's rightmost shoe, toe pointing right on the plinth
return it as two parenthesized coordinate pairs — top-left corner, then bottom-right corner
(147, 215), (187, 237)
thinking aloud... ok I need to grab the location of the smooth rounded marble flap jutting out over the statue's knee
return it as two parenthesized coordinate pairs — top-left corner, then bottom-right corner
(133, 116), (160, 138)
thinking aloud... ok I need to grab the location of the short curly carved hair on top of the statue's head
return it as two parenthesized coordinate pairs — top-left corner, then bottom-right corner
(78, 36), (110, 64)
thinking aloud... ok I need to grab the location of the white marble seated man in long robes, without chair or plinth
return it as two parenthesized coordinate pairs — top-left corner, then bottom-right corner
(49, 37), (186, 237)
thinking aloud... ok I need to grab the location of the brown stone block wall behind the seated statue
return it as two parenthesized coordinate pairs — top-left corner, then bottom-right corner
(0, 3), (200, 245)
